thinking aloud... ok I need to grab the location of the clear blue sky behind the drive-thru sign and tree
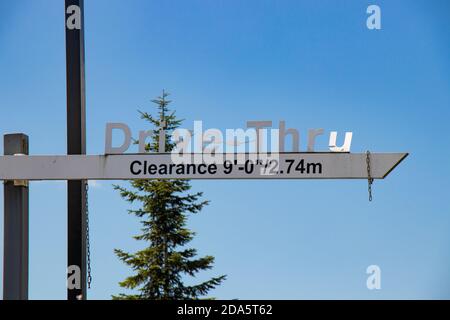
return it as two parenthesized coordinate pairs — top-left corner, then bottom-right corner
(0, 0), (450, 299)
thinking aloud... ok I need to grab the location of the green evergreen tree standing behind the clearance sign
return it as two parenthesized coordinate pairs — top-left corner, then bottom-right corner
(113, 91), (225, 300)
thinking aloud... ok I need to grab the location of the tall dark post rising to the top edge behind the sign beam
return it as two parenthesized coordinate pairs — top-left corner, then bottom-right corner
(65, 0), (86, 300)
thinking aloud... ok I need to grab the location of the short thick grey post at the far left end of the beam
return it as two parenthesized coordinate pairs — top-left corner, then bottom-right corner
(3, 134), (28, 300)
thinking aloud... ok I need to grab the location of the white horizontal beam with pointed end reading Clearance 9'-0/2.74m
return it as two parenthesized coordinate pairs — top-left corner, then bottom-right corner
(0, 153), (408, 180)
